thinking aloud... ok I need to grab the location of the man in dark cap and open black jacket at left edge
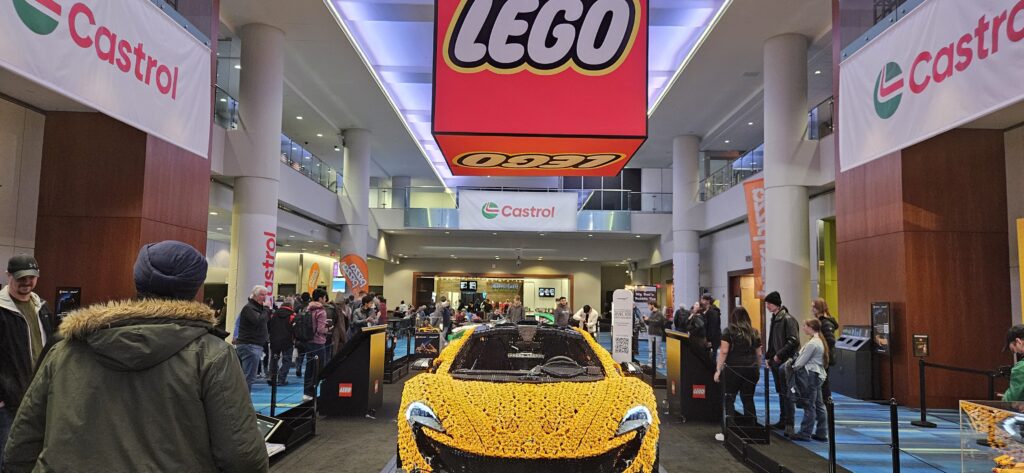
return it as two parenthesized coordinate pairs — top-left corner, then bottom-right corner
(0, 255), (57, 469)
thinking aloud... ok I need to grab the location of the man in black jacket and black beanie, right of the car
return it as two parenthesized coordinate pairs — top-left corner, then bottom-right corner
(765, 292), (800, 429)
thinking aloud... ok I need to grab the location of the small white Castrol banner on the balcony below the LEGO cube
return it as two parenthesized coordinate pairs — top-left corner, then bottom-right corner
(459, 190), (577, 231)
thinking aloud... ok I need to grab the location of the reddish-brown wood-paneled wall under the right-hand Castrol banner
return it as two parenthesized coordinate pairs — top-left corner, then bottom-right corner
(836, 129), (1012, 406)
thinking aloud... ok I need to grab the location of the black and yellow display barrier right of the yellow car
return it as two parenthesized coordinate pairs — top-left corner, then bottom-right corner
(665, 330), (722, 422)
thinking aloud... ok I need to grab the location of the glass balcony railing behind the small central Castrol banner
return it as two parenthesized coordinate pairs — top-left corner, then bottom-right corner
(370, 186), (672, 213)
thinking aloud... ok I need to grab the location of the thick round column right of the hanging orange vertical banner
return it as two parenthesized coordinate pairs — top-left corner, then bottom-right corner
(764, 34), (811, 319)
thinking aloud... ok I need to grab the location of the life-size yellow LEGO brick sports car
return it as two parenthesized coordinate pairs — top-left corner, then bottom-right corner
(398, 324), (658, 473)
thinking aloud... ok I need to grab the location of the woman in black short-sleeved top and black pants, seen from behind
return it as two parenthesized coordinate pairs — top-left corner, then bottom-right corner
(715, 307), (762, 421)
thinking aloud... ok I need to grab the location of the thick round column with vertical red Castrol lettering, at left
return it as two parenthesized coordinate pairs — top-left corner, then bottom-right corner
(225, 24), (285, 332)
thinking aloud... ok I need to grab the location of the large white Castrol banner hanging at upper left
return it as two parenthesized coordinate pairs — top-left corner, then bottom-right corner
(0, 0), (212, 158)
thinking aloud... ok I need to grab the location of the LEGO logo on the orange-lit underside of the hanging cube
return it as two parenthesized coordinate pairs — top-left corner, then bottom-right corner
(452, 152), (626, 169)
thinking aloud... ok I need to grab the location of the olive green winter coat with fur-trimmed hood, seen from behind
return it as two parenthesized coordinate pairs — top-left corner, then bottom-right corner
(4, 299), (268, 473)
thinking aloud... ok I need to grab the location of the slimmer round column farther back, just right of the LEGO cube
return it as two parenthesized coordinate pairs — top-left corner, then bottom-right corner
(672, 135), (700, 308)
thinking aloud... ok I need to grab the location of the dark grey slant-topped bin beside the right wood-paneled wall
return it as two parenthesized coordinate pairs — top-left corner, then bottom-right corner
(828, 326), (871, 399)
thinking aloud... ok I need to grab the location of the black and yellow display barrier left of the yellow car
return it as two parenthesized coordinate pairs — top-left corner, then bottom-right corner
(317, 326), (387, 416)
